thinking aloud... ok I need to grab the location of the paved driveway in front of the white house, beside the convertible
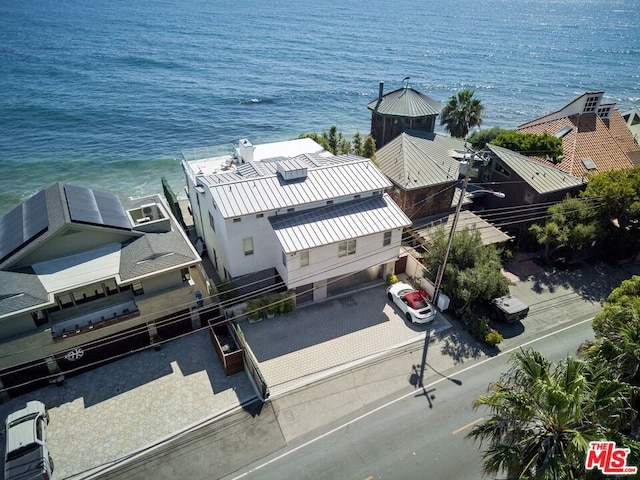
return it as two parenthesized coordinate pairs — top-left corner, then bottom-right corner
(240, 284), (452, 396)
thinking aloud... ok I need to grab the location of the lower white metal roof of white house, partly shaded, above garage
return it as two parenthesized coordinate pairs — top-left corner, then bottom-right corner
(269, 193), (411, 253)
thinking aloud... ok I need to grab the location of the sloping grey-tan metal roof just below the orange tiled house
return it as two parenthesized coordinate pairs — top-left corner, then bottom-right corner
(487, 144), (584, 193)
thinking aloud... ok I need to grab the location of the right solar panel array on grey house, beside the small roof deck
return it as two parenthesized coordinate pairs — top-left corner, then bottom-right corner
(64, 185), (131, 230)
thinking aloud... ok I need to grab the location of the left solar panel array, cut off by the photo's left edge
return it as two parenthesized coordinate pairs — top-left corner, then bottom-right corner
(0, 190), (49, 261)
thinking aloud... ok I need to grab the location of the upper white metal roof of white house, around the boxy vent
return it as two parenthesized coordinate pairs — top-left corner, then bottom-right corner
(202, 157), (391, 218)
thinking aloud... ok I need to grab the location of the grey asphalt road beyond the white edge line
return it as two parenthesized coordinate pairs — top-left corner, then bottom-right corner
(227, 321), (593, 480)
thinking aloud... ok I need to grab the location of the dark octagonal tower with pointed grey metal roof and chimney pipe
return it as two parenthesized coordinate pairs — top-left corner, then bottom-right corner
(367, 78), (442, 150)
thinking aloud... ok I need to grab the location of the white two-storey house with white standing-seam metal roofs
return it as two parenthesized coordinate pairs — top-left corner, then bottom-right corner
(182, 138), (411, 302)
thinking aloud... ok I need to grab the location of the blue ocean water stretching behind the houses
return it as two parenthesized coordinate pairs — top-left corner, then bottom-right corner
(0, 0), (640, 214)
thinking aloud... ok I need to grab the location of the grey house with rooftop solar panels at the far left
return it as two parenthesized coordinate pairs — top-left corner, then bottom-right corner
(0, 183), (203, 398)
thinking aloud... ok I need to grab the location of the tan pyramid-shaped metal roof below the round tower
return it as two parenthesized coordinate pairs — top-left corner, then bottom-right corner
(376, 130), (466, 190)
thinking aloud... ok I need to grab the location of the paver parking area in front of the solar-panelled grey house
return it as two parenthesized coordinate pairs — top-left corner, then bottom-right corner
(0, 331), (255, 479)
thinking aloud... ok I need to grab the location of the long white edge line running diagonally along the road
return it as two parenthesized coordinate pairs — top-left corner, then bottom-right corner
(232, 317), (593, 480)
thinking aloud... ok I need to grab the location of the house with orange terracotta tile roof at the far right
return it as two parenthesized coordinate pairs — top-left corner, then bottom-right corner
(517, 91), (640, 178)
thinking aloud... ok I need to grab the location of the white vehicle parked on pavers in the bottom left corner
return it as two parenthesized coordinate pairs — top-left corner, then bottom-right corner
(4, 400), (53, 480)
